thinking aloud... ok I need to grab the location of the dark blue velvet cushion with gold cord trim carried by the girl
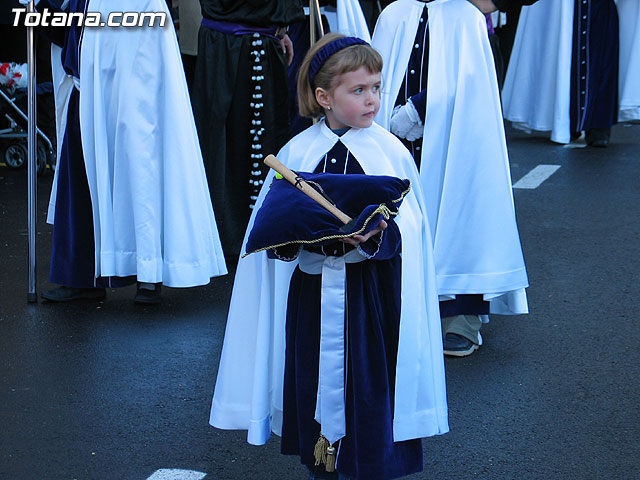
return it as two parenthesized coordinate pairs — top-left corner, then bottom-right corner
(244, 172), (411, 255)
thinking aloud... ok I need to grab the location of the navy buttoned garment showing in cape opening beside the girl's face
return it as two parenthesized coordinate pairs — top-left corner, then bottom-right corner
(396, 2), (429, 164)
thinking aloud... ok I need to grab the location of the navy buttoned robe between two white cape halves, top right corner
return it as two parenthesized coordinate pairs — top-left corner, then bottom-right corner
(570, 0), (620, 132)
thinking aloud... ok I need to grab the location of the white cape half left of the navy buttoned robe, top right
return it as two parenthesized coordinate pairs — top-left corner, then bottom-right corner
(502, 0), (574, 143)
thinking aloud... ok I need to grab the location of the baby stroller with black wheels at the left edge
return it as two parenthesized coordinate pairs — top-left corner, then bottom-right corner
(0, 83), (56, 175)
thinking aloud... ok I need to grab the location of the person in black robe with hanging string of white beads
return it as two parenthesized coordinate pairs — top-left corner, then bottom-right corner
(193, 0), (304, 258)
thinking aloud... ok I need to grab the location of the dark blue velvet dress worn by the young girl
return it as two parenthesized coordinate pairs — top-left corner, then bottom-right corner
(281, 142), (423, 480)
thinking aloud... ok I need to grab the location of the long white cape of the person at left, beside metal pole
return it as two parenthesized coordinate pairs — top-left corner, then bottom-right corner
(48, 0), (227, 287)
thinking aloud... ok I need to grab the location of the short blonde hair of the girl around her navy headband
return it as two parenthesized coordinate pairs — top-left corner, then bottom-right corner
(298, 33), (382, 118)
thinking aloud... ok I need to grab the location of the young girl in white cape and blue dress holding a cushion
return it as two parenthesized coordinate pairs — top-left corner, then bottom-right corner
(210, 34), (448, 480)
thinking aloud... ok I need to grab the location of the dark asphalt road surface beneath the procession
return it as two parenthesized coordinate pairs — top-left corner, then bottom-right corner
(0, 125), (640, 480)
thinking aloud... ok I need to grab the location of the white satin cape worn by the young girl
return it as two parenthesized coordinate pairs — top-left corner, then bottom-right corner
(210, 121), (449, 445)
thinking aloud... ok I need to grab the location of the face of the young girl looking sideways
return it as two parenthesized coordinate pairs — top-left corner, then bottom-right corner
(316, 67), (380, 130)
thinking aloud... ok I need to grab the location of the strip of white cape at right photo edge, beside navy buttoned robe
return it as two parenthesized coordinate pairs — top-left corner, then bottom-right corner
(616, 0), (640, 122)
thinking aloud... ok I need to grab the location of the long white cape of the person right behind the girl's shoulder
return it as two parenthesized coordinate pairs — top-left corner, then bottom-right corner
(372, 0), (528, 314)
